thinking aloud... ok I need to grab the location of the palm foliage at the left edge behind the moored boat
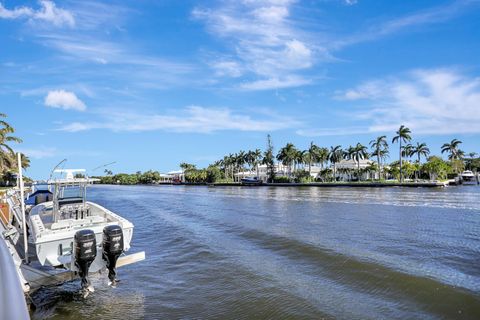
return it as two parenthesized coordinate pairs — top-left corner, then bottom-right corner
(0, 113), (30, 186)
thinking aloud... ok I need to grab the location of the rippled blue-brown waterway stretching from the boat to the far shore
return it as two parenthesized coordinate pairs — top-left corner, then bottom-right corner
(32, 186), (480, 319)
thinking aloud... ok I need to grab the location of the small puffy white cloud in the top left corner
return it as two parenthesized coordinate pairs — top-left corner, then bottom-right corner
(0, 0), (75, 27)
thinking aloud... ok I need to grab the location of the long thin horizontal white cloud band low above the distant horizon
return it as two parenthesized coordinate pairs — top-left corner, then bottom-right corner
(59, 106), (299, 133)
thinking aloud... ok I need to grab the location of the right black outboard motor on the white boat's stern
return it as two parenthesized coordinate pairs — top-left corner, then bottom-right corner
(102, 225), (123, 286)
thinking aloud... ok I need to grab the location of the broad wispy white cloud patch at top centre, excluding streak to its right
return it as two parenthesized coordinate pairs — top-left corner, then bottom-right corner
(193, 0), (316, 90)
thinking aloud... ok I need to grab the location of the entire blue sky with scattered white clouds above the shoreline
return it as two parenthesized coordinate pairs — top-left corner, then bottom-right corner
(0, 0), (480, 178)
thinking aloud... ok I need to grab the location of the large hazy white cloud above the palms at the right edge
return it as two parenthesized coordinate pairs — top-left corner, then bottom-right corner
(337, 69), (480, 134)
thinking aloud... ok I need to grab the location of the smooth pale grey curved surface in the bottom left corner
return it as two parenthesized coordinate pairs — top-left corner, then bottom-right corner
(0, 235), (30, 319)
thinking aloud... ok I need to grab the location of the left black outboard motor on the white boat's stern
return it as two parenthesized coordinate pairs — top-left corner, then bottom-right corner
(74, 229), (97, 291)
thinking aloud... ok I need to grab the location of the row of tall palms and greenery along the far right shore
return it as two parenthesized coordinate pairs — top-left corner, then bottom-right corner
(181, 125), (480, 182)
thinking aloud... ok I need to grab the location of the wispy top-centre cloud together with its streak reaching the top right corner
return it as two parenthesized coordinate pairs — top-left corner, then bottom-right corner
(192, 0), (479, 90)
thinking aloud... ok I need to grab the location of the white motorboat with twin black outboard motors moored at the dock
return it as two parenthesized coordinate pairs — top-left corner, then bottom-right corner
(0, 165), (145, 304)
